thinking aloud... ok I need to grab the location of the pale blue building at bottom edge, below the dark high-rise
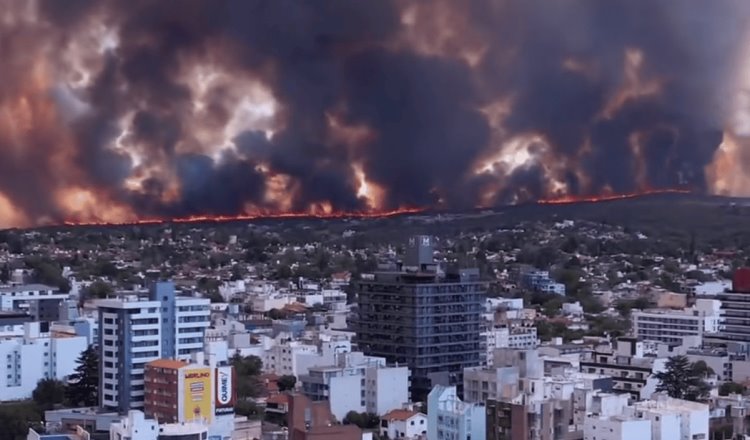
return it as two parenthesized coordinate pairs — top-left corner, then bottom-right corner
(427, 385), (487, 440)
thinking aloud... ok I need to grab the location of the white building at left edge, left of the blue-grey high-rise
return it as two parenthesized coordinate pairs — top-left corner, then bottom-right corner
(0, 322), (88, 401)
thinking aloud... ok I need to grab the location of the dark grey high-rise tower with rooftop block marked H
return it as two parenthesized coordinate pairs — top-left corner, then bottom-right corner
(354, 236), (486, 400)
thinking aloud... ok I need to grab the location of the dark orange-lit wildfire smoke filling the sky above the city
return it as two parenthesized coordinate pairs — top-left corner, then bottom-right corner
(0, 0), (750, 226)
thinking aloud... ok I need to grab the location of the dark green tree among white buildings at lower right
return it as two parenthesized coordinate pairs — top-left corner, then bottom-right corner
(655, 355), (711, 401)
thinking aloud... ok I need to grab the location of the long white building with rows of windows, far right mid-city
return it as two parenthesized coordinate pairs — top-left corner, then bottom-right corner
(632, 298), (721, 343)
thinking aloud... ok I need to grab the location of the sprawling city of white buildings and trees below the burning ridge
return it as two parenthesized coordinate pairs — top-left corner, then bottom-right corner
(0, 195), (750, 440)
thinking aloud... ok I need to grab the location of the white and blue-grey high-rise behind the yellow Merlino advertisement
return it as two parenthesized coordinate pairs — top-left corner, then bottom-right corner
(98, 282), (211, 412)
